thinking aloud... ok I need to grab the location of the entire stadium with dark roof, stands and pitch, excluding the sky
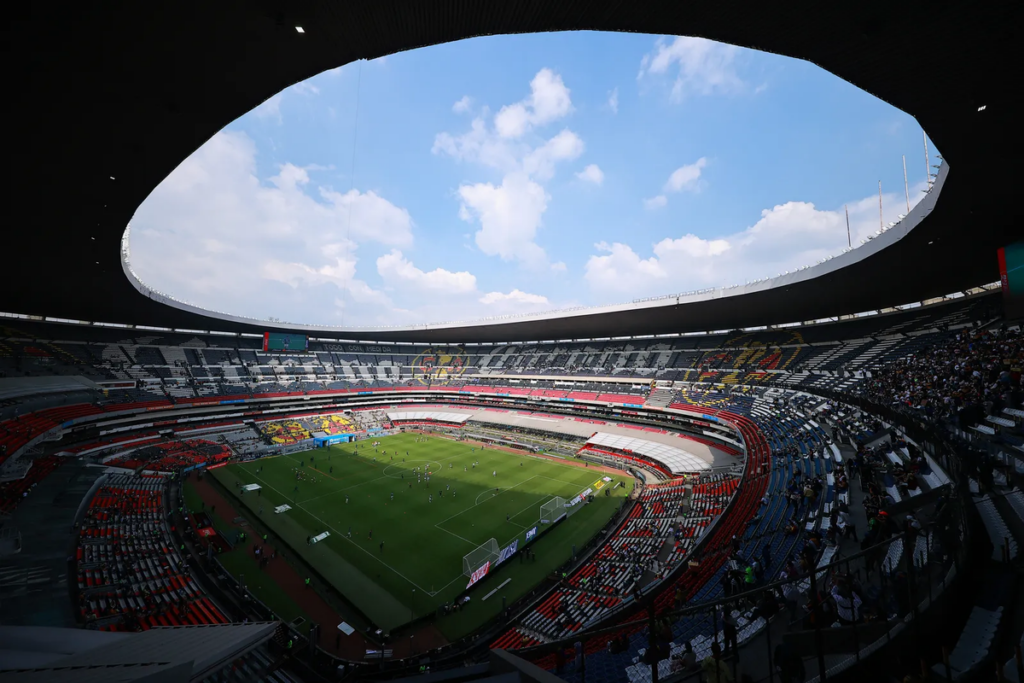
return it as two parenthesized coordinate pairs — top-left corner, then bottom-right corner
(0, 0), (1024, 683)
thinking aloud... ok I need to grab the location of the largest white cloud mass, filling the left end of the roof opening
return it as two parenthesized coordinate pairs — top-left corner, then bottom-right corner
(131, 132), (413, 324)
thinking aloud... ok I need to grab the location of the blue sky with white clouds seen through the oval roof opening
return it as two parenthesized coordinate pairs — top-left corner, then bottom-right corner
(131, 33), (936, 327)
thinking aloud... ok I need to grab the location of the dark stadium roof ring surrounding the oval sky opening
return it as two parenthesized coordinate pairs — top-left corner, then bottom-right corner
(8, 0), (1022, 342)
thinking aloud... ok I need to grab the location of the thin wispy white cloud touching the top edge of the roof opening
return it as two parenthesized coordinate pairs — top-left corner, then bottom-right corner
(637, 36), (745, 101)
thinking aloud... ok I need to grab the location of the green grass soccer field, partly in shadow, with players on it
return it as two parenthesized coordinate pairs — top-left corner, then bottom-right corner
(211, 434), (632, 637)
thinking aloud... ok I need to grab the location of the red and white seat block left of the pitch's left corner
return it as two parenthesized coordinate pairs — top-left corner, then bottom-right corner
(75, 475), (228, 631)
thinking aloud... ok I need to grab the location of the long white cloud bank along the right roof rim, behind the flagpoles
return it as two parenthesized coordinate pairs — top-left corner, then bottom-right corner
(585, 183), (924, 296)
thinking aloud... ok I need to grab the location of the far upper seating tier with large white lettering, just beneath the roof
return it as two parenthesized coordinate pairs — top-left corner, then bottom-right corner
(0, 295), (996, 405)
